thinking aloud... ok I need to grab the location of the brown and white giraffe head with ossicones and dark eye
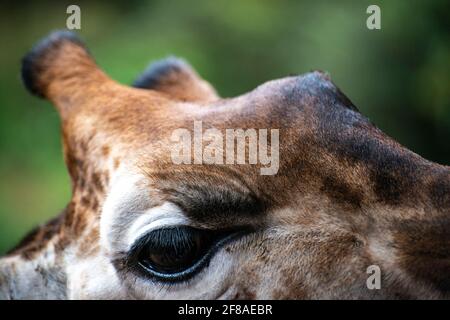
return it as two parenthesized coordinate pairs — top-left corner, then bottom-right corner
(0, 31), (450, 299)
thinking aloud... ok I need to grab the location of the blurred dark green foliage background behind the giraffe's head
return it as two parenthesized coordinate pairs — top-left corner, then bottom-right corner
(0, 0), (450, 253)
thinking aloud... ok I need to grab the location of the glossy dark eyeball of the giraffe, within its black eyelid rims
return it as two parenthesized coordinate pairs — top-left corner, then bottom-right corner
(140, 227), (206, 273)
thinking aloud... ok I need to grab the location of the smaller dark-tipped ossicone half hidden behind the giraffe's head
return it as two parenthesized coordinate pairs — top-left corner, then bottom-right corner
(133, 57), (219, 101)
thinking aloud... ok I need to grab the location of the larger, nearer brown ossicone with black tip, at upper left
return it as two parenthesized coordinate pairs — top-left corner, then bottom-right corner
(21, 31), (112, 116)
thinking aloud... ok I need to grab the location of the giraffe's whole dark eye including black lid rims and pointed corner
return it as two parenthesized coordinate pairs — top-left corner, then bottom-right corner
(134, 226), (246, 282)
